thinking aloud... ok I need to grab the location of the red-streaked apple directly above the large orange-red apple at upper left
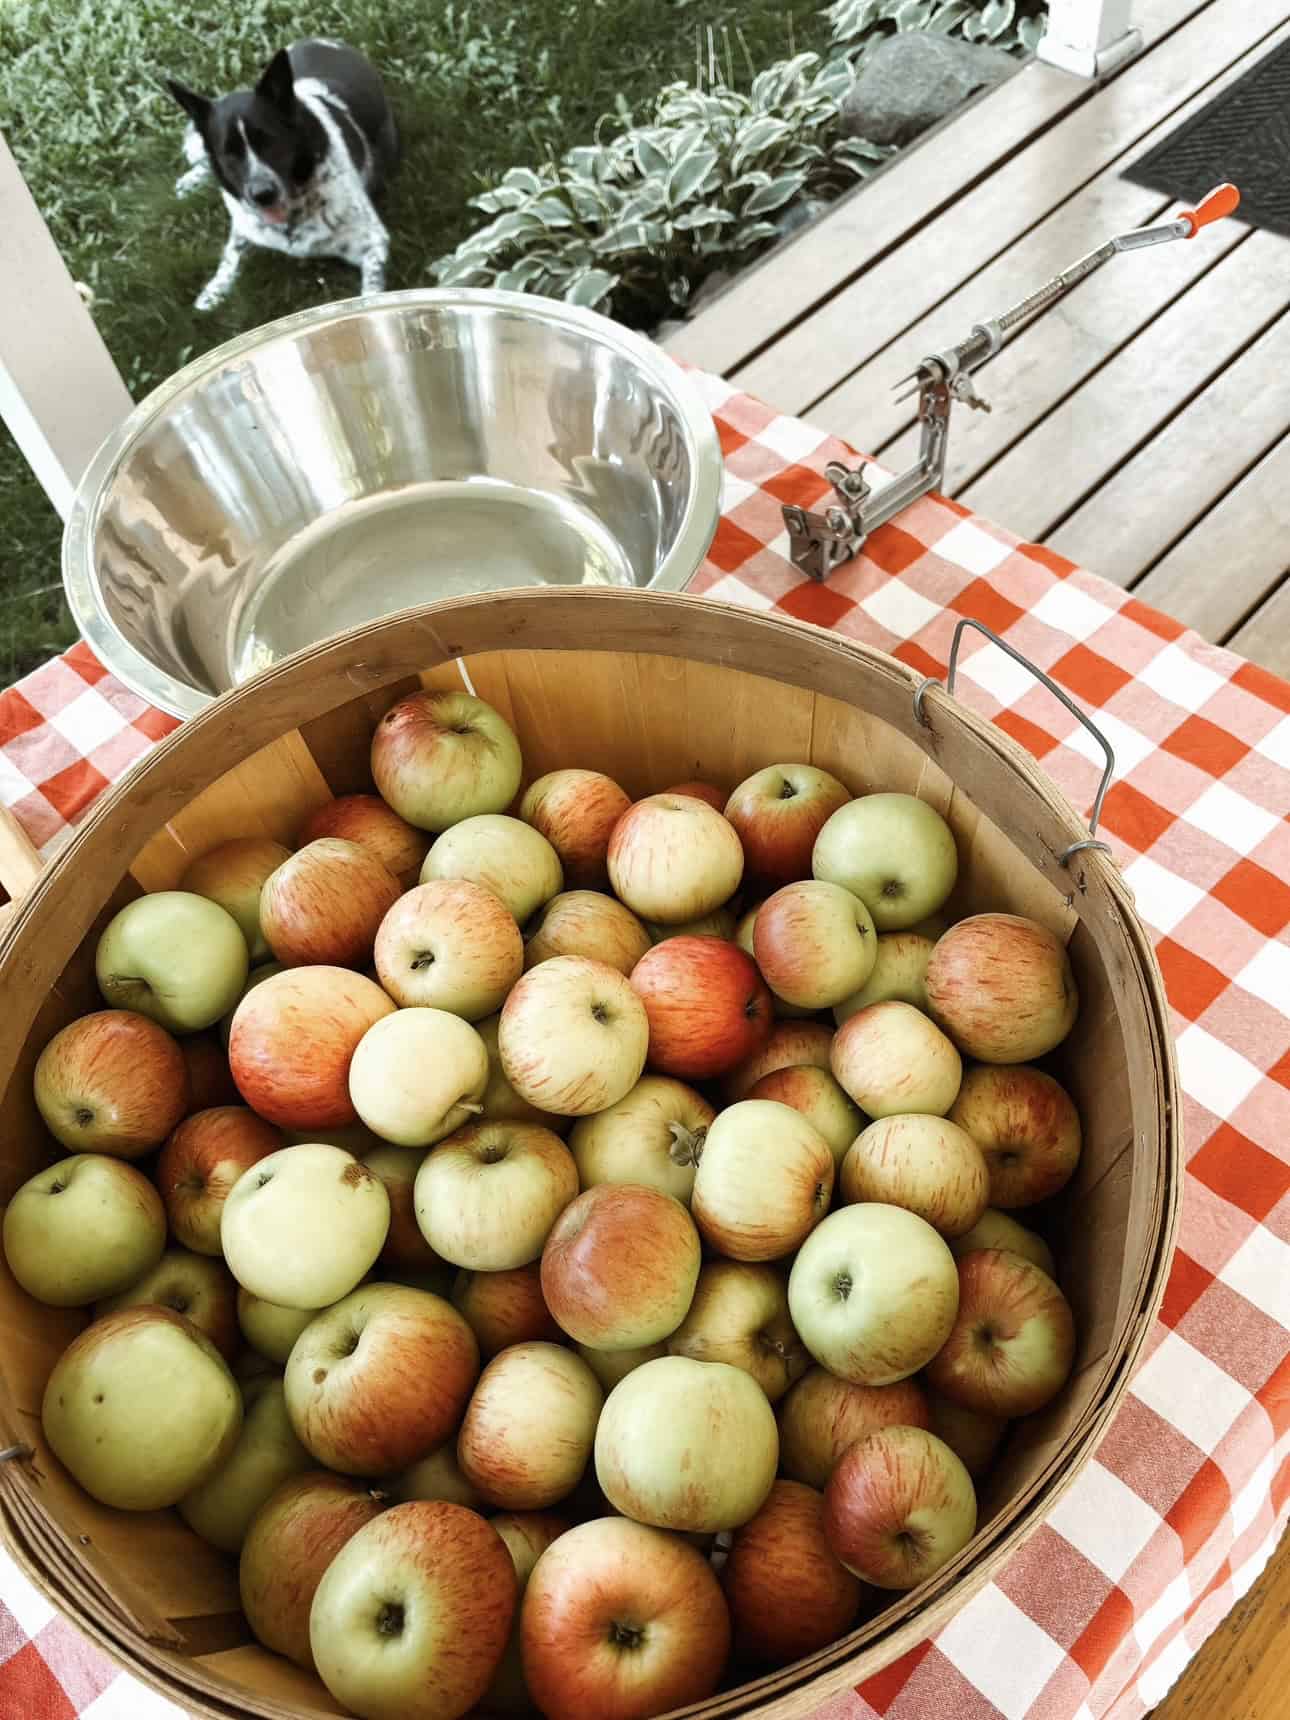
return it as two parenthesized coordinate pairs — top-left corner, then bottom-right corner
(260, 836), (401, 968)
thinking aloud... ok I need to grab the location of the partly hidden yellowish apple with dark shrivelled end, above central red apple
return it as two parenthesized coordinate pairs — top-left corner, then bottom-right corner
(569, 1075), (717, 1206)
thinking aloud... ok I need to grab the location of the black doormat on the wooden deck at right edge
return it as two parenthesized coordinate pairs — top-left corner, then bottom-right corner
(1125, 43), (1290, 237)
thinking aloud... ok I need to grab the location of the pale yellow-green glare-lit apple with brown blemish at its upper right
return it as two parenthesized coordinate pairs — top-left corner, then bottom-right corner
(220, 1142), (390, 1309)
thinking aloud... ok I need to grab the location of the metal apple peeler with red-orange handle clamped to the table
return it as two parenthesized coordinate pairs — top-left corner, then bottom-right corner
(784, 184), (1240, 580)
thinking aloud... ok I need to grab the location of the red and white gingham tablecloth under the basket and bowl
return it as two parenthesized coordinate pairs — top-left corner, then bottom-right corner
(0, 377), (1290, 1720)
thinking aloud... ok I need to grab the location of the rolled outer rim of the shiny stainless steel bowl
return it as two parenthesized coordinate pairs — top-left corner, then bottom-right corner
(62, 287), (722, 717)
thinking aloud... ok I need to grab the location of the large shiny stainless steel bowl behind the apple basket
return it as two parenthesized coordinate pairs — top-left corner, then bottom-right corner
(62, 289), (721, 717)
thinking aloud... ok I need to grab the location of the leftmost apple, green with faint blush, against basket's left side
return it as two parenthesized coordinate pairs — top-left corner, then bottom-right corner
(3, 1152), (165, 1307)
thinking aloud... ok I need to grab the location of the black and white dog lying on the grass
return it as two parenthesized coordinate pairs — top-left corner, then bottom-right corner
(165, 41), (399, 311)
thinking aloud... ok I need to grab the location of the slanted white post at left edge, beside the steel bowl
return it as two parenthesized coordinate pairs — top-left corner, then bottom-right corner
(0, 134), (134, 518)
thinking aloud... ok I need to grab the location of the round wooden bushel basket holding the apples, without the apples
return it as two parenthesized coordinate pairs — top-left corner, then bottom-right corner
(0, 590), (1182, 1720)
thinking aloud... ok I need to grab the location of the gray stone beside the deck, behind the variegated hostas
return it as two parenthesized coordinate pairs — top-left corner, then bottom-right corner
(841, 31), (1017, 144)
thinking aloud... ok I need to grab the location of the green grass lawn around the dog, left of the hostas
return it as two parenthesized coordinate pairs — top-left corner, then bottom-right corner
(0, 0), (827, 686)
